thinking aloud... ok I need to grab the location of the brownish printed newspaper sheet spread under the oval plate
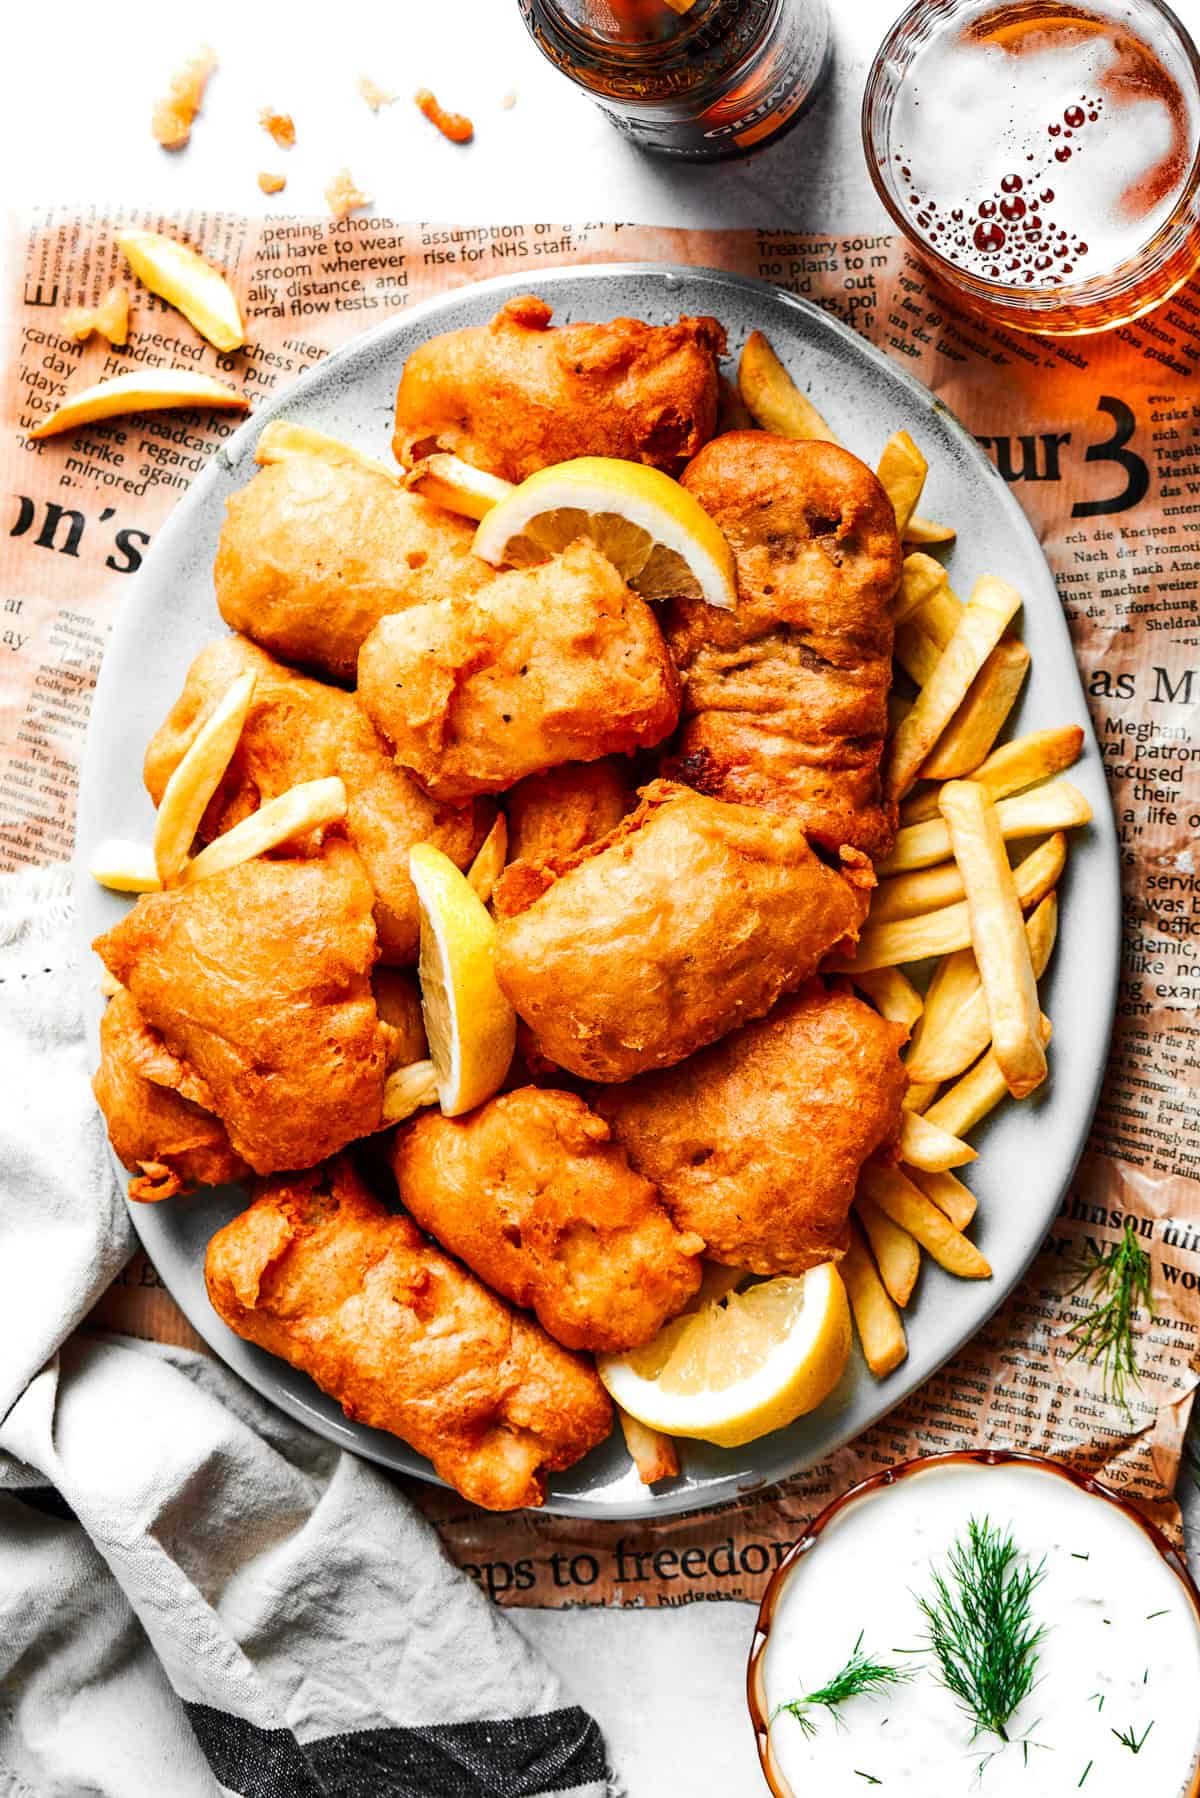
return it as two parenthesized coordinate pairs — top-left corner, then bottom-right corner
(0, 212), (1200, 1606)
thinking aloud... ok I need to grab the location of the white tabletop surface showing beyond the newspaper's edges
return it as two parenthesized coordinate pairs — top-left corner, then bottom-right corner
(0, 0), (1200, 1798)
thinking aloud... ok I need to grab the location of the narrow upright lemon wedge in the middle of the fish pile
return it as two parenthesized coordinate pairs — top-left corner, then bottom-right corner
(408, 843), (516, 1118)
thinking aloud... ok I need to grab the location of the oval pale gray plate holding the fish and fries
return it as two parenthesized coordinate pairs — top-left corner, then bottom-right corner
(77, 264), (1121, 1518)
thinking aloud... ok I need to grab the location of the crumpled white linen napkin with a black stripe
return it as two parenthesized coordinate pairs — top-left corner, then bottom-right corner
(0, 868), (617, 1798)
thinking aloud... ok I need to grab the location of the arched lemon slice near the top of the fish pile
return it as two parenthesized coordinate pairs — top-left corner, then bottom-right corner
(473, 455), (738, 611)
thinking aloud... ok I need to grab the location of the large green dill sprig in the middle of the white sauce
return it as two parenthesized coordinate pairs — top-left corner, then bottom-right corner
(918, 1518), (1045, 1742)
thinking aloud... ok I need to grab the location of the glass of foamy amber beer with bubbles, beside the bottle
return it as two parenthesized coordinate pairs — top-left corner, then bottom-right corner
(862, 0), (1200, 336)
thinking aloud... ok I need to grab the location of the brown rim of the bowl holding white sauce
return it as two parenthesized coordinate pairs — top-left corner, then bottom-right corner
(747, 1449), (1200, 1798)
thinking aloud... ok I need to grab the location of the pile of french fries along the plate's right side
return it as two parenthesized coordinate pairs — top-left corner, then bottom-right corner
(738, 331), (1092, 1377)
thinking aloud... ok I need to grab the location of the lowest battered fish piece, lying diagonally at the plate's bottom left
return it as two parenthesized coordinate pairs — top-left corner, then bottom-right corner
(205, 1158), (612, 1510)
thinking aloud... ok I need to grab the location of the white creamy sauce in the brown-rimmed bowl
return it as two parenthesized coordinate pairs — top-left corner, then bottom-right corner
(761, 1464), (1200, 1798)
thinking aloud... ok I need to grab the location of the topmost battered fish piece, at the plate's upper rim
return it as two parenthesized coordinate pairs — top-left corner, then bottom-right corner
(392, 295), (725, 480)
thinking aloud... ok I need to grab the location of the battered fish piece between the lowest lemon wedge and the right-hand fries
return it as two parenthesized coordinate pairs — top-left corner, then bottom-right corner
(594, 980), (907, 1273)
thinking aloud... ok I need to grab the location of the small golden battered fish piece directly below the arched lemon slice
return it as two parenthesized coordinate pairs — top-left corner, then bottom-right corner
(358, 538), (678, 800)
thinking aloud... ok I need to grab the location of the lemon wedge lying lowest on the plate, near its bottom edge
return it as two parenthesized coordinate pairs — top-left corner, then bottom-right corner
(596, 1262), (851, 1449)
